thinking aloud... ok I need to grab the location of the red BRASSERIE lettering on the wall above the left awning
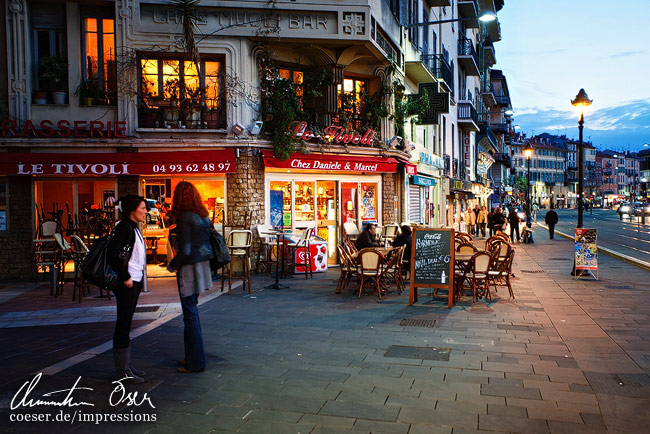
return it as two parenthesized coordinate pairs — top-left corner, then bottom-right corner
(0, 119), (127, 139)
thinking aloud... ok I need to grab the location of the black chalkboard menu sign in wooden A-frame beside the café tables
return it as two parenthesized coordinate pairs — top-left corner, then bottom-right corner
(409, 228), (454, 307)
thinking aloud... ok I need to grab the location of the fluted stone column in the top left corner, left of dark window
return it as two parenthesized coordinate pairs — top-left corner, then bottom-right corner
(5, 0), (31, 124)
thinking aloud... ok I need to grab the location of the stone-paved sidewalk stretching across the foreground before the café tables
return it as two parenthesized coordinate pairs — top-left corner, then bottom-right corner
(0, 234), (650, 434)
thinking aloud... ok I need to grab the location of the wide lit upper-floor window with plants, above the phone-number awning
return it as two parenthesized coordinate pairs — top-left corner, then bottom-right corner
(138, 54), (226, 129)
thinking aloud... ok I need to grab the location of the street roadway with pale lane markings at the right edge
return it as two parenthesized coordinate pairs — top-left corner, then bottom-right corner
(537, 208), (650, 263)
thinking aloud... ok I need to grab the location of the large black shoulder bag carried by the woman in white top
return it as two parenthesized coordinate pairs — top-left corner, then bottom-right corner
(81, 229), (132, 292)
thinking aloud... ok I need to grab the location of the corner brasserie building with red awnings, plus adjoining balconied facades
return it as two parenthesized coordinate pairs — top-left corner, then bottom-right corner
(0, 0), (509, 280)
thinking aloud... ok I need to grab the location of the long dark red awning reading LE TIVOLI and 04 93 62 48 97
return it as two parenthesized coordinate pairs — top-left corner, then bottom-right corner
(0, 149), (237, 176)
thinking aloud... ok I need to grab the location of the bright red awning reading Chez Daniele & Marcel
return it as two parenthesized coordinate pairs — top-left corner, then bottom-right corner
(262, 151), (397, 173)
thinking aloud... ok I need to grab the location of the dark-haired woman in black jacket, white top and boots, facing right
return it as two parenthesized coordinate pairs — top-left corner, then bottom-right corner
(106, 195), (147, 383)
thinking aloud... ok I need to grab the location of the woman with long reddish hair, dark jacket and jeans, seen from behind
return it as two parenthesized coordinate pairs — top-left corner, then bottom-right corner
(169, 181), (213, 373)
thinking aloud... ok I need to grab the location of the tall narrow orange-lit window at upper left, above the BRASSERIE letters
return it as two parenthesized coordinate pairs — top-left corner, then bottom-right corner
(81, 12), (117, 105)
